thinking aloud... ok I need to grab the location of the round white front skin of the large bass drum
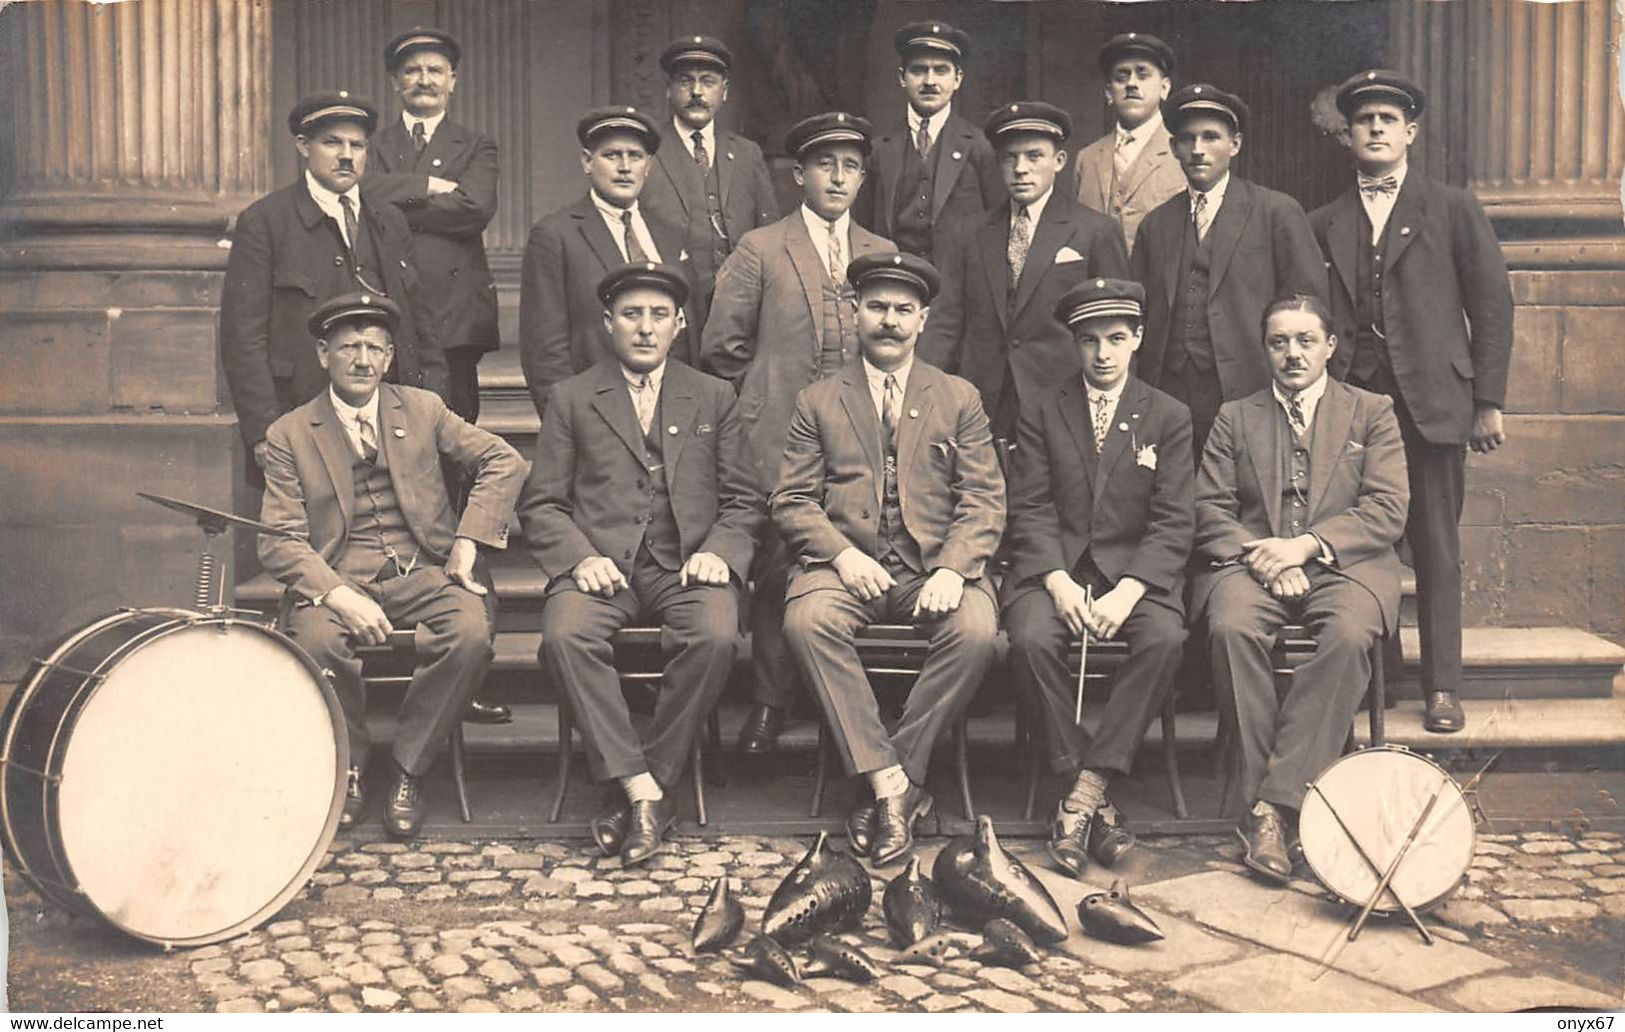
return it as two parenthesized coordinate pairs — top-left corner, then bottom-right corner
(57, 621), (348, 944)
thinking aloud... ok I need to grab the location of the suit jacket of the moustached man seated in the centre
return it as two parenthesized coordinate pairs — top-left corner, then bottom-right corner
(772, 359), (1004, 598)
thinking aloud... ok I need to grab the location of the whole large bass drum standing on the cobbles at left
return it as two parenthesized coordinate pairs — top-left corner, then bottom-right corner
(0, 609), (349, 947)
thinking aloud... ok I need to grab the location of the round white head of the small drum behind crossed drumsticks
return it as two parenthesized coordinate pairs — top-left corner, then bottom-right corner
(1298, 746), (1477, 913)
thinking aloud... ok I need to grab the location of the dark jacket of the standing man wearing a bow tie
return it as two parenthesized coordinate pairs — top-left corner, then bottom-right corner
(1310, 172), (1513, 444)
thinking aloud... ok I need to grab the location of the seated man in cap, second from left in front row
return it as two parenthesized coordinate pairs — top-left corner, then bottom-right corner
(520, 262), (767, 865)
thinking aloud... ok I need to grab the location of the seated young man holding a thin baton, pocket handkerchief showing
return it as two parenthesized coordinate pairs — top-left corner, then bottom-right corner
(1003, 278), (1194, 876)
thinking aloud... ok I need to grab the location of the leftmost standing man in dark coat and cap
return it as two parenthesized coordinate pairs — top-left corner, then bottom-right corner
(219, 89), (445, 481)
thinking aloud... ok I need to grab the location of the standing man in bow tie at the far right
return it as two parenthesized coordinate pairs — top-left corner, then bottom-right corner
(1310, 70), (1513, 731)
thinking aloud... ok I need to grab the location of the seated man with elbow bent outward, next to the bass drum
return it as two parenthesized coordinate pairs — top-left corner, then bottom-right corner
(260, 294), (527, 839)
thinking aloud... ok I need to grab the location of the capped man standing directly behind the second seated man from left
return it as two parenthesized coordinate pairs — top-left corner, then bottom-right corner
(518, 106), (702, 414)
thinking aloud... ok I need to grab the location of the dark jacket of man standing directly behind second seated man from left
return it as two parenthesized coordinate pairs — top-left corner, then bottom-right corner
(518, 195), (699, 414)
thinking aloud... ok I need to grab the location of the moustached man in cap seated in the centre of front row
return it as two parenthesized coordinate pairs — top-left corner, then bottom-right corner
(772, 254), (1004, 866)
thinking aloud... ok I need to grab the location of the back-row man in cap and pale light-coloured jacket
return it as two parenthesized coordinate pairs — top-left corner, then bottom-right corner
(1076, 33), (1185, 249)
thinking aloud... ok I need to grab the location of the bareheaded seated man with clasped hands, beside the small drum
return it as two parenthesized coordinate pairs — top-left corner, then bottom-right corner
(1191, 294), (1411, 882)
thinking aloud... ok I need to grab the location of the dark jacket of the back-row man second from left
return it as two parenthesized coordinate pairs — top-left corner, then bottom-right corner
(639, 119), (778, 299)
